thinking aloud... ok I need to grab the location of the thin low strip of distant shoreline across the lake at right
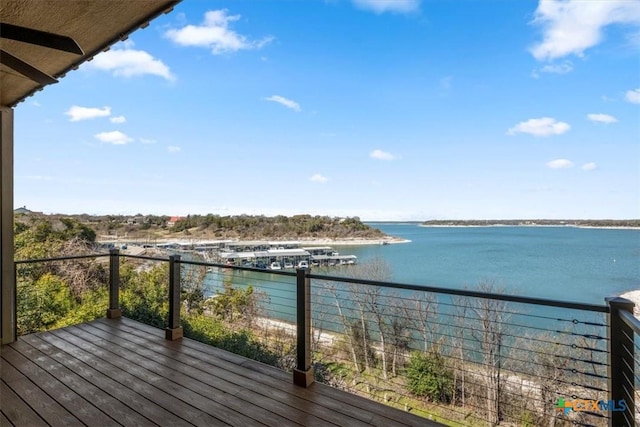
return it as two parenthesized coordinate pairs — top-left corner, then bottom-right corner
(420, 219), (640, 227)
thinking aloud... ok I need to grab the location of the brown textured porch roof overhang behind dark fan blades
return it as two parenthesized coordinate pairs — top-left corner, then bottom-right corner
(0, 0), (180, 107)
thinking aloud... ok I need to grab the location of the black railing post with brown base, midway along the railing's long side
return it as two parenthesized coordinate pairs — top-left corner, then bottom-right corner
(293, 268), (314, 387)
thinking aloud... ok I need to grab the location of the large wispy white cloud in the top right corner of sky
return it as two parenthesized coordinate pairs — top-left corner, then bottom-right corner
(531, 0), (640, 61)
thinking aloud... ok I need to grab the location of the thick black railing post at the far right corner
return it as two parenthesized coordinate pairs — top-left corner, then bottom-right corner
(605, 297), (635, 427)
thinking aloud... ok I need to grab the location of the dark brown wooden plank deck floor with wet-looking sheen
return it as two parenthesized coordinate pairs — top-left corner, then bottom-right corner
(0, 319), (440, 427)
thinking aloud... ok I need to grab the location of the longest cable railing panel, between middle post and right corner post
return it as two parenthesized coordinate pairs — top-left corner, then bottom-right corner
(310, 274), (608, 425)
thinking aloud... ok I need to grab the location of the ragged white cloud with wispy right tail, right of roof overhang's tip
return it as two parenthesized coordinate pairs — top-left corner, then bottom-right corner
(165, 9), (273, 55)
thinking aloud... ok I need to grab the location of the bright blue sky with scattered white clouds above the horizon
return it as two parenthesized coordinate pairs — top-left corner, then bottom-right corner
(15, 0), (640, 220)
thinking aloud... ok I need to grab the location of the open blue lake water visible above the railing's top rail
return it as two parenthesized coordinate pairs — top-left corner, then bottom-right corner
(339, 223), (640, 304)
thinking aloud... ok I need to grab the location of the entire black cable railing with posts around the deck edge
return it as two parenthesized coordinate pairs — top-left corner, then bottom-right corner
(15, 249), (640, 426)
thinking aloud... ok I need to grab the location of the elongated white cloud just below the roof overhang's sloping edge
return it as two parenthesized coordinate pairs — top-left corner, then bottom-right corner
(87, 49), (175, 81)
